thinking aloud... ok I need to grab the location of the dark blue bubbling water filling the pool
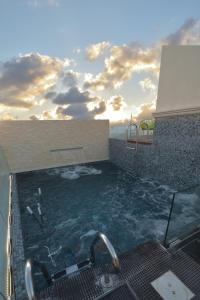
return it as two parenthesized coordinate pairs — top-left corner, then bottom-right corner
(17, 162), (172, 290)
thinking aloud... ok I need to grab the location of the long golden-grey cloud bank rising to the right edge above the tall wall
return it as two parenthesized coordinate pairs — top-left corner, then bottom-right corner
(84, 19), (200, 91)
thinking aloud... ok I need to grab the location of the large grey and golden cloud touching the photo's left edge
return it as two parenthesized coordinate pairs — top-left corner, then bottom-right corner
(0, 53), (69, 109)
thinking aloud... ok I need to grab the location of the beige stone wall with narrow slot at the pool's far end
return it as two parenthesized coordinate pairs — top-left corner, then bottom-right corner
(0, 120), (109, 173)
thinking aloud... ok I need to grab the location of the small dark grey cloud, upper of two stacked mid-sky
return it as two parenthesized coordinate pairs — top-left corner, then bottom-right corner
(45, 87), (98, 105)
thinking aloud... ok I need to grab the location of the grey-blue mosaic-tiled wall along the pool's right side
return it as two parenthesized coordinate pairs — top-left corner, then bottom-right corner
(110, 114), (200, 188)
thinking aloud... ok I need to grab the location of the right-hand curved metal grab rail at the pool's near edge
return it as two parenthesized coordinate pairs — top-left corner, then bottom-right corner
(90, 232), (120, 272)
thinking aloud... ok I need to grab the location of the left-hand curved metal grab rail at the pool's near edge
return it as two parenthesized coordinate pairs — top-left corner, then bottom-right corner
(25, 259), (53, 300)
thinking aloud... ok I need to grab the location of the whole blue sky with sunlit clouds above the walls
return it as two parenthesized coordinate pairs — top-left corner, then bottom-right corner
(0, 0), (200, 123)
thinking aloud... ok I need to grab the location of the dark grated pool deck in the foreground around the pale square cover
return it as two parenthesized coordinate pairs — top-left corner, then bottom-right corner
(38, 242), (200, 300)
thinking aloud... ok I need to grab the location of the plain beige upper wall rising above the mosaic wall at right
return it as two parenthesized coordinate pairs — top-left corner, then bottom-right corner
(155, 46), (200, 116)
